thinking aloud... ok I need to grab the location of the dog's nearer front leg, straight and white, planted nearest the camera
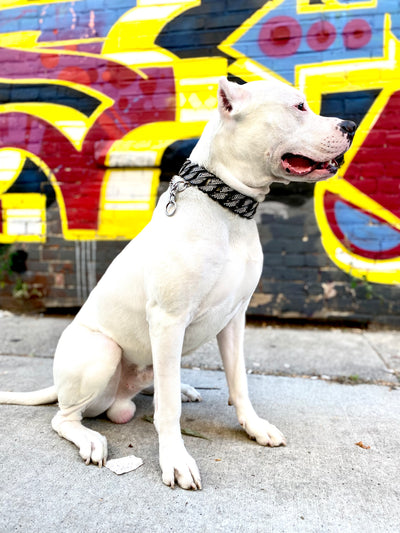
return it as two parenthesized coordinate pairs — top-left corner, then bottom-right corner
(148, 307), (201, 490)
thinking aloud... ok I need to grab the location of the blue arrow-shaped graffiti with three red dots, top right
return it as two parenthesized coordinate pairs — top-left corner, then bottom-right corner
(233, 0), (400, 83)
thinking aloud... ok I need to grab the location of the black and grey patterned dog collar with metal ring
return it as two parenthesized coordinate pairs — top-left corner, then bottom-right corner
(166, 159), (258, 218)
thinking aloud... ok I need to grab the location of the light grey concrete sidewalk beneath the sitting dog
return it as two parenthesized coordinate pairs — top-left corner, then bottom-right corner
(0, 312), (400, 533)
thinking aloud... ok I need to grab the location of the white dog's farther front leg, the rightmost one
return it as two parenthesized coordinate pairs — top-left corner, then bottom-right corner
(217, 308), (286, 446)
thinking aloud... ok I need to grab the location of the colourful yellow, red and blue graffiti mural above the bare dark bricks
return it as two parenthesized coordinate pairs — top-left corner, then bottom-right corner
(0, 0), (400, 284)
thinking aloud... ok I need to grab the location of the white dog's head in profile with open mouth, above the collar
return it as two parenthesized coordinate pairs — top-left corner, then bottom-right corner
(209, 78), (356, 192)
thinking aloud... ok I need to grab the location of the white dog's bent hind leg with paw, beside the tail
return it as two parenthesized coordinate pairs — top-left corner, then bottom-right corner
(52, 324), (121, 466)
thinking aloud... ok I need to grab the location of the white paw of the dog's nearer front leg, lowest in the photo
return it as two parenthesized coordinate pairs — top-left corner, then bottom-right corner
(160, 446), (201, 490)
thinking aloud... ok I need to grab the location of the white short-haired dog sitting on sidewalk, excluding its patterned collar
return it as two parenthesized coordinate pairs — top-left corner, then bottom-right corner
(0, 79), (356, 489)
